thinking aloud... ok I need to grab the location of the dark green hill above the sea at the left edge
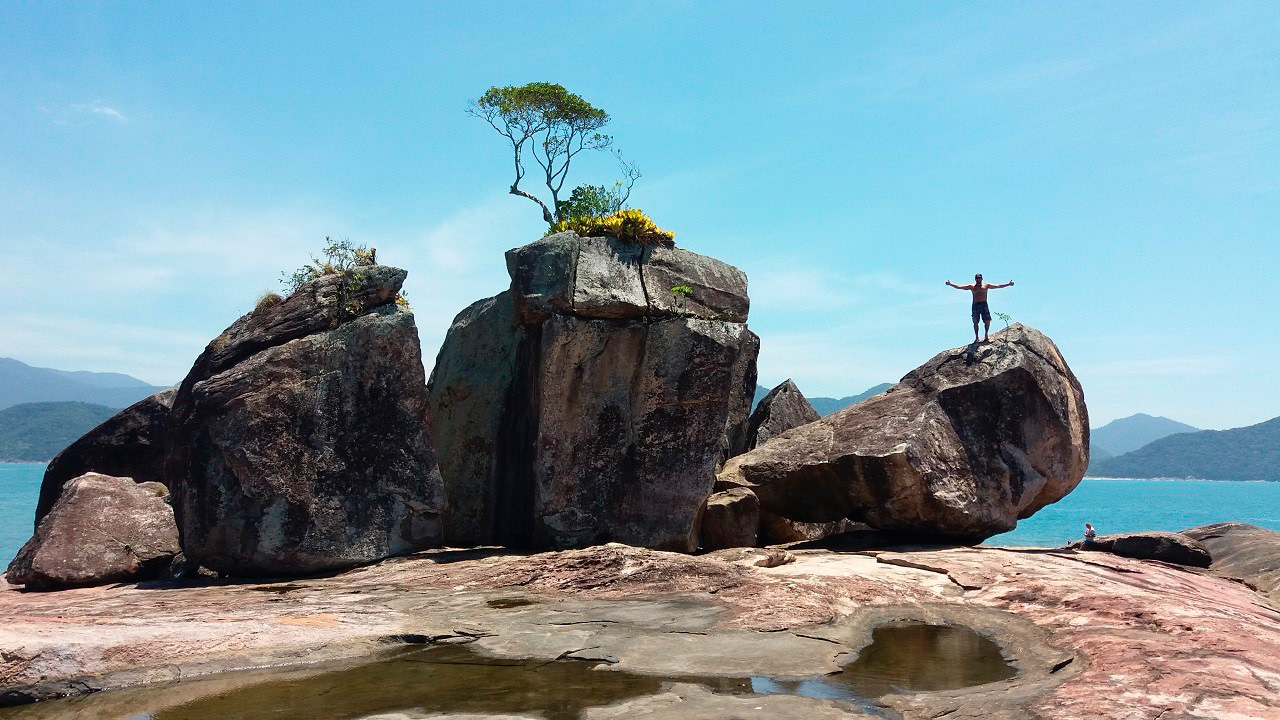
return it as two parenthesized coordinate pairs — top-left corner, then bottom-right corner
(0, 401), (116, 462)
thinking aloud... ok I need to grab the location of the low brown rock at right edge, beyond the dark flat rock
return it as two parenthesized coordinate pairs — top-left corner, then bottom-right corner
(1183, 523), (1280, 605)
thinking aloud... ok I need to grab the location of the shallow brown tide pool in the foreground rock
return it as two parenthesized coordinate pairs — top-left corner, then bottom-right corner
(0, 623), (1016, 720)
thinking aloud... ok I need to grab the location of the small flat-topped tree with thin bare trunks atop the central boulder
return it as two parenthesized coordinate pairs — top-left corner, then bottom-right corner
(467, 82), (640, 225)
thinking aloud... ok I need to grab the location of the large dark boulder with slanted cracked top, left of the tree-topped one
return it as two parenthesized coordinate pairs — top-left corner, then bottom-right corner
(165, 265), (444, 575)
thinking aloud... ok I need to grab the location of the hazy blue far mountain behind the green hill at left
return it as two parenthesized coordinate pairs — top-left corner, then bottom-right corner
(0, 357), (165, 409)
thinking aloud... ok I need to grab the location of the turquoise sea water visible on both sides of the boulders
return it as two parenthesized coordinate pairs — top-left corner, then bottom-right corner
(0, 464), (1280, 565)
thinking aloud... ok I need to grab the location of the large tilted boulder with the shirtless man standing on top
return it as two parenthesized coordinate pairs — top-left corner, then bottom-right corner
(719, 324), (1089, 542)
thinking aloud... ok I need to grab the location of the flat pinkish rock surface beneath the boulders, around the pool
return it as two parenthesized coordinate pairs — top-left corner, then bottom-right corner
(0, 546), (1280, 720)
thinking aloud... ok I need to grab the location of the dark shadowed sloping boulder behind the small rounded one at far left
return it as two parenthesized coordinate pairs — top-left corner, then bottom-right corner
(36, 388), (178, 527)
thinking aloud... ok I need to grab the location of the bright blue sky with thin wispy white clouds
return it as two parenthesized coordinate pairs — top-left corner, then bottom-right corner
(0, 0), (1280, 428)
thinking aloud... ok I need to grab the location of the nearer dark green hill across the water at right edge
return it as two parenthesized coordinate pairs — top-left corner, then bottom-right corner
(1089, 418), (1280, 480)
